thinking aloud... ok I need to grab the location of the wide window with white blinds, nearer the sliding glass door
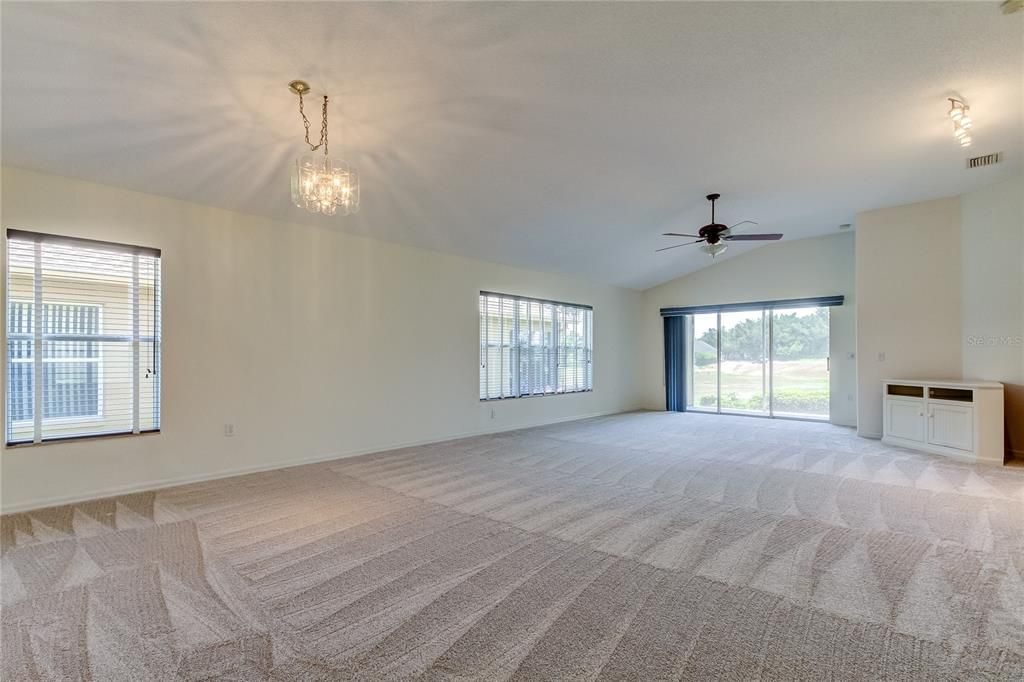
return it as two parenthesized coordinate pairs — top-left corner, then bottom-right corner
(480, 292), (594, 400)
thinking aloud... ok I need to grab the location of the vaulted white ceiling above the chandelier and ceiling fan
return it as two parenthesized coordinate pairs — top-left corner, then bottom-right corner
(2, 1), (1024, 288)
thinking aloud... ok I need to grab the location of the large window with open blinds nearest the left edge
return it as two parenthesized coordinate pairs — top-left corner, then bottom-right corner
(6, 229), (160, 444)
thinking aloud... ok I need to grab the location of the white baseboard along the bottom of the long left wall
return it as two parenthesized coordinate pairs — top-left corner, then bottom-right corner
(0, 412), (625, 514)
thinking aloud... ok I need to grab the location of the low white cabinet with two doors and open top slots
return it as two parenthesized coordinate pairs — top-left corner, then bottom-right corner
(882, 379), (1004, 464)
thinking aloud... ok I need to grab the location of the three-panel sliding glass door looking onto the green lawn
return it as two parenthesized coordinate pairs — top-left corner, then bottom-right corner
(686, 306), (828, 419)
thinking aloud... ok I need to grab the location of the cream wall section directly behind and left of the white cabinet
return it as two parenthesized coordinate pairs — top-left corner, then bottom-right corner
(856, 197), (963, 438)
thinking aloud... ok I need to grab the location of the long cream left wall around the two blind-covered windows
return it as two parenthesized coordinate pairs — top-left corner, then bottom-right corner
(0, 168), (641, 510)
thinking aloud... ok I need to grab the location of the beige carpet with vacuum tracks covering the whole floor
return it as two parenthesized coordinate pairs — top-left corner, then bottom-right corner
(0, 411), (1024, 681)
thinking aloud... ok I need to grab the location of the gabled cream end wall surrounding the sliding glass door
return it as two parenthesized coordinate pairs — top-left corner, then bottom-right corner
(641, 233), (857, 426)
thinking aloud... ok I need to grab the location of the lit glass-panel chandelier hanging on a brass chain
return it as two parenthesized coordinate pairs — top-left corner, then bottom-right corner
(288, 81), (359, 215)
